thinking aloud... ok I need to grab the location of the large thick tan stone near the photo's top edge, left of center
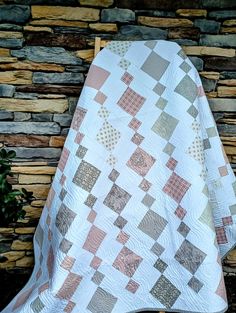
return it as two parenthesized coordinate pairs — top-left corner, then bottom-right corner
(31, 5), (99, 21)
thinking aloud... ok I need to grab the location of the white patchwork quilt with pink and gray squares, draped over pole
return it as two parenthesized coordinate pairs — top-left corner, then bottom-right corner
(2, 40), (236, 313)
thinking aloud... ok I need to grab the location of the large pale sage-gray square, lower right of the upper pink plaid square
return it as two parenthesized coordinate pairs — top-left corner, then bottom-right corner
(151, 111), (179, 140)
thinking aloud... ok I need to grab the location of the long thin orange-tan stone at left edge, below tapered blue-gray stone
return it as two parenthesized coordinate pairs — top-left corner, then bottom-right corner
(0, 58), (65, 72)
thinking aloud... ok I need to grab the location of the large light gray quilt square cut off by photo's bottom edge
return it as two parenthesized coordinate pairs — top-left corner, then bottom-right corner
(87, 287), (118, 313)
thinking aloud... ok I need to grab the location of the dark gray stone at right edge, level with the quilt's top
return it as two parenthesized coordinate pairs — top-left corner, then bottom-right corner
(199, 34), (236, 47)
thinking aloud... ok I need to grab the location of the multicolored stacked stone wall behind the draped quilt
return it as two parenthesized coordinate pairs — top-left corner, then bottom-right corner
(0, 0), (236, 312)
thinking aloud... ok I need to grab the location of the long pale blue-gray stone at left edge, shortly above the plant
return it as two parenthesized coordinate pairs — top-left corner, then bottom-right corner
(0, 122), (61, 135)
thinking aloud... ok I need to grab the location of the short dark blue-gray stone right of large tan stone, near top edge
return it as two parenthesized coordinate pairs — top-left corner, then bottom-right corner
(101, 8), (135, 23)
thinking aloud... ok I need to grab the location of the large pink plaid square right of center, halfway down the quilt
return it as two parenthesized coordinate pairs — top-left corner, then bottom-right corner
(162, 172), (191, 203)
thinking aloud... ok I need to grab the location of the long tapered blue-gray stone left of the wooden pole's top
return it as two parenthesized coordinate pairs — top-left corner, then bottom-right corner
(11, 46), (82, 65)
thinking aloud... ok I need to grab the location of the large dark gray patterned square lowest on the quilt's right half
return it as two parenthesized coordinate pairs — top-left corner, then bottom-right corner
(150, 275), (181, 309)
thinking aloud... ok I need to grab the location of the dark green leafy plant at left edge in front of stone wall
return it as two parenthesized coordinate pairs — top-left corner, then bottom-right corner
(0, 148), (35, 227)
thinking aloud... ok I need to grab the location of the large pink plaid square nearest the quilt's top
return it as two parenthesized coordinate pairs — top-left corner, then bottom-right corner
(117, 87), (145, 116)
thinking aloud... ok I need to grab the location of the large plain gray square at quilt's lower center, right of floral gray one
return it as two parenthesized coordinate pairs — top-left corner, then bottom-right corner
(138, 210), (168, 240)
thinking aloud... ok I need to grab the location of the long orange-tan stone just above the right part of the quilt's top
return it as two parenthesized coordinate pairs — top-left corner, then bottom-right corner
(138, 16), (193, 27)
